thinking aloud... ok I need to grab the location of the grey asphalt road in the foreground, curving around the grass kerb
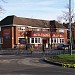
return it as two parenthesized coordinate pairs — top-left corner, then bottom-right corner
(0, 55), (75, 75)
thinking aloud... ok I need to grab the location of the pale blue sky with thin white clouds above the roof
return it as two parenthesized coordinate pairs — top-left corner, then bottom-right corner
(0, 0), (75, 20)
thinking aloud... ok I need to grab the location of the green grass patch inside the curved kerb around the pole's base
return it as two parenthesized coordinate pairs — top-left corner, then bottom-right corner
(48, 54), (75, 64)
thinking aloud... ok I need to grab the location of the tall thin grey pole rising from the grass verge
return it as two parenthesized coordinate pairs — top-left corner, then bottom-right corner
(69, 0), (72, 55)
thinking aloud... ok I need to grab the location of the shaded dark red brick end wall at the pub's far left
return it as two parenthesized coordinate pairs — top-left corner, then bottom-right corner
(2, 27), (12, 48)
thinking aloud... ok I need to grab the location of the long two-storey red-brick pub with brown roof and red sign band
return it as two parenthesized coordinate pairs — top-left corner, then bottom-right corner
(0, 15), (68, 48)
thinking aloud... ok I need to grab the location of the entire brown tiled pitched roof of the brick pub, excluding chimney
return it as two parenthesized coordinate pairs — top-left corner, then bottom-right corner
(0, 15), (64, 28)
